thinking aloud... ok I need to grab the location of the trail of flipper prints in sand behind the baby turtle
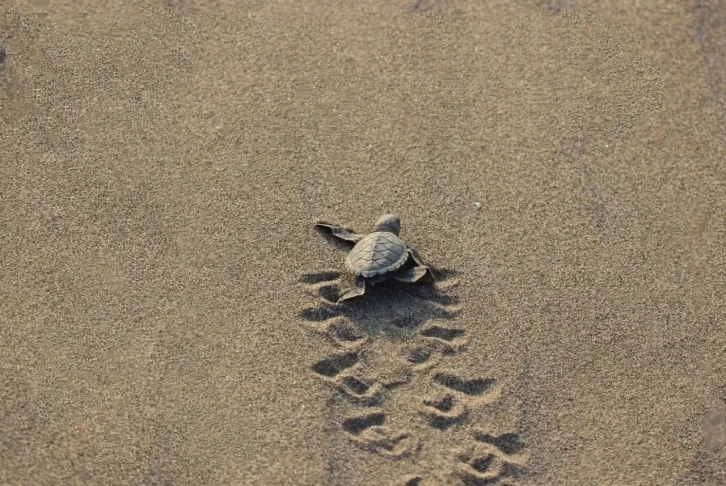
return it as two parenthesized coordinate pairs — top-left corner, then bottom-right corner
(299, 270), (528, 486)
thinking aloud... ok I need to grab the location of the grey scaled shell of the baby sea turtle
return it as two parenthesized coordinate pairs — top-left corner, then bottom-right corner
(345, 231), (408, 278)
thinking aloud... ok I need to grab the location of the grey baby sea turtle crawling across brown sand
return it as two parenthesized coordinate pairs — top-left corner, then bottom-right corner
(315, 214), (434, 302)
